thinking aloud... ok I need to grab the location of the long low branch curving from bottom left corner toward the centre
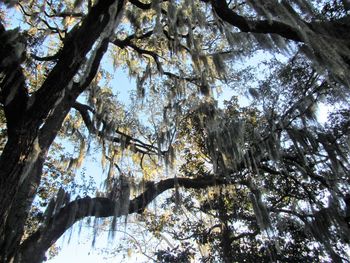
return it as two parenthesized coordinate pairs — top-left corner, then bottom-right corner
(15, 176), (228, 263)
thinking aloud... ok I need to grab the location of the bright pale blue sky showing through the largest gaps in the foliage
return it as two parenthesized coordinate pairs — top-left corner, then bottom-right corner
(0, 3), (331, 263)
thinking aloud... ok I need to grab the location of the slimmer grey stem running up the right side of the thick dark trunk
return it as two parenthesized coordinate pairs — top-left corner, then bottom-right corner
(2, 38), (108, 258)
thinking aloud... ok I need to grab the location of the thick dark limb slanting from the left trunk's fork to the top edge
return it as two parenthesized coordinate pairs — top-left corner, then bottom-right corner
(29, 0), (124, 128)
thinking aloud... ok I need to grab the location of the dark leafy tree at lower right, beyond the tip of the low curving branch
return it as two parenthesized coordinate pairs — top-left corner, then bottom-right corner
(148, 55), (348, 262)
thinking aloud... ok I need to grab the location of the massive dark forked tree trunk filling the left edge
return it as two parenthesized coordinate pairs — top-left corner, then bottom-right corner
(0, 0), (124, 262)
